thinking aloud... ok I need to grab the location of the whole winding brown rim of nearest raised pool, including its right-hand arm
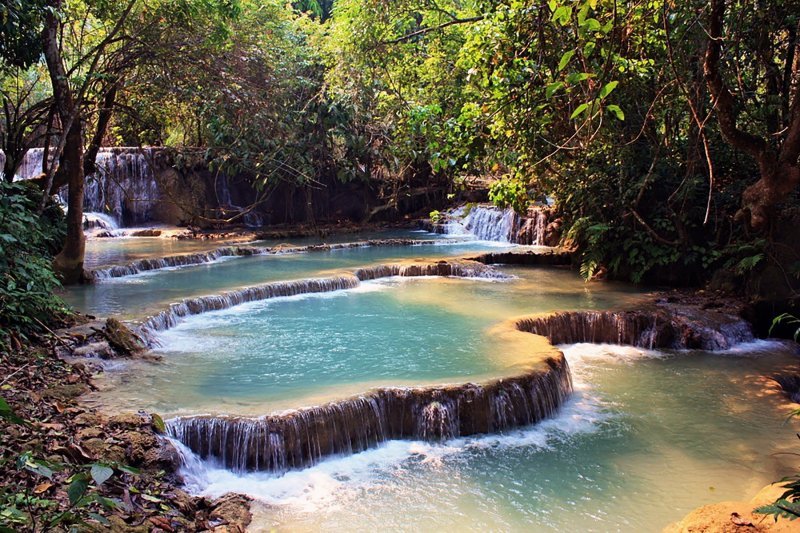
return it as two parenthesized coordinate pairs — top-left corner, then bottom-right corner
(168, 302), (752, 474)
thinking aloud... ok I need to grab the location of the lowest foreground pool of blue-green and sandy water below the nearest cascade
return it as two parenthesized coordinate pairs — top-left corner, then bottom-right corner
(183, 344), (797, 532)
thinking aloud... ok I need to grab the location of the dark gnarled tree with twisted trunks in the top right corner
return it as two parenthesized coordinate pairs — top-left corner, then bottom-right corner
(703, 0), (800, 230)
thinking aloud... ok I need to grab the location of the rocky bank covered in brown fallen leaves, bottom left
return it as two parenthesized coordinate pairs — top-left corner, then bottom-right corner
(0, 322), (250, 533)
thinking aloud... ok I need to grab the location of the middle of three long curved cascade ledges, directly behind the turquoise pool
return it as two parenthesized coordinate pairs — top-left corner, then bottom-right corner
(139, 260), (507, 344)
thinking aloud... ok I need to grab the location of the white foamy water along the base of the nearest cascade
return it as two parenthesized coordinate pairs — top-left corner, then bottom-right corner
(172, 386), (608, 512)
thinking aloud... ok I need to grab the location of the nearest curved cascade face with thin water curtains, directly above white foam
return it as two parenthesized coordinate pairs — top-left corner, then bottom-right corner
(167, 354), (572, 472)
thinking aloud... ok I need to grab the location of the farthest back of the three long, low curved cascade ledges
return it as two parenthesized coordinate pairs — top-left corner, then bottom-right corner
(91, 239), (468, 281)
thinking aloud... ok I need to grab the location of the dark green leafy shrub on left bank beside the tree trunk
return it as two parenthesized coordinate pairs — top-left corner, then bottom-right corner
(0, 183), (66, 351)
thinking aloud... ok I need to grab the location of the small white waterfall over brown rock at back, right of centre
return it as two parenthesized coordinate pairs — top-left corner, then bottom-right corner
(425, 205), (555, 246)
